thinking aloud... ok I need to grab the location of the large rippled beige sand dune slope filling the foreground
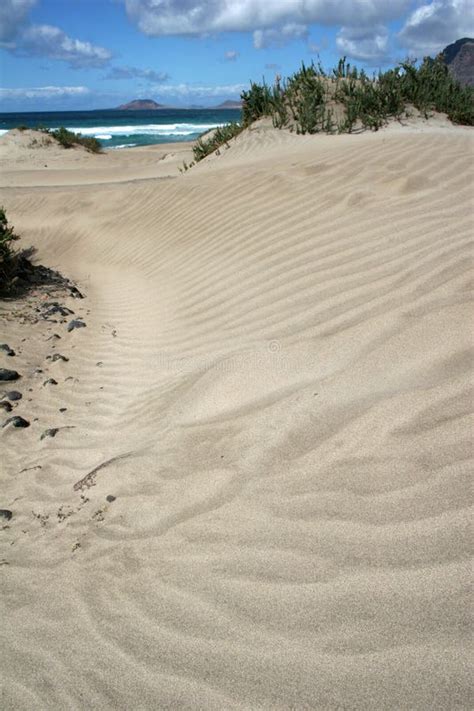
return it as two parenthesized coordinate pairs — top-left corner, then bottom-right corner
(0, 125), (473, 711)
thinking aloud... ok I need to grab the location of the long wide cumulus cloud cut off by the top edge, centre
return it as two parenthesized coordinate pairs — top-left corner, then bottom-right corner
(123, 0), (411, 37)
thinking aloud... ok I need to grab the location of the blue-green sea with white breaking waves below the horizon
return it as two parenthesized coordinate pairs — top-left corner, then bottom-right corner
(0, 109), (240, 149)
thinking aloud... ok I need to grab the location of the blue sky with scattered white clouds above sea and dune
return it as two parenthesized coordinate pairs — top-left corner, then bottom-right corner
(0, 0), (474, 111)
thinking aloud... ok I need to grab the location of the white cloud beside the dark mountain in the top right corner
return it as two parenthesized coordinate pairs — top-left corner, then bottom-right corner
(398, 0), (474, 55)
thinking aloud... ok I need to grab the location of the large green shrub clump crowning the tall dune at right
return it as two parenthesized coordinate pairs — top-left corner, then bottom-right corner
(241, 56), (474, 134)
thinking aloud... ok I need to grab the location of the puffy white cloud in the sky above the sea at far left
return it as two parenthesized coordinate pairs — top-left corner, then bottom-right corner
(17, 25), (112, 69)
